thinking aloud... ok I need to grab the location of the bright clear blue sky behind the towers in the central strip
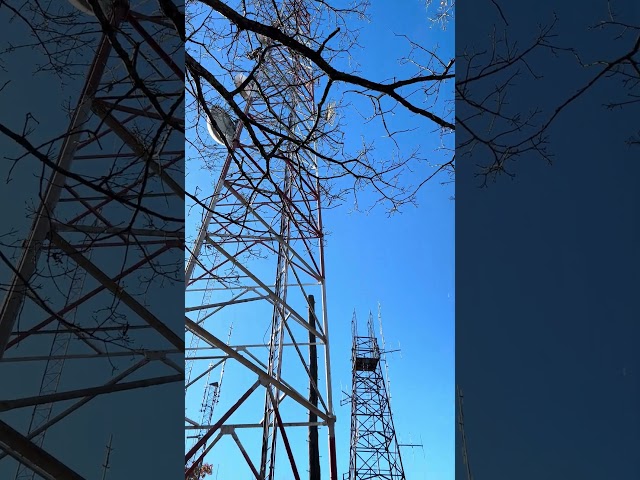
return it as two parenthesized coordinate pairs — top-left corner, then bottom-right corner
(186, 1), (455, 480)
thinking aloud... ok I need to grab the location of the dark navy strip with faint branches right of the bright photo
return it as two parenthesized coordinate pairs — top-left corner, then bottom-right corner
(456, 0), (640, 480)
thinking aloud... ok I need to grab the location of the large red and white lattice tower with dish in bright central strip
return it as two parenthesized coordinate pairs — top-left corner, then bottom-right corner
(185, 0), (336, 480)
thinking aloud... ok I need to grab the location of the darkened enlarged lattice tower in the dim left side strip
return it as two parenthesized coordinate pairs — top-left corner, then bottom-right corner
(0, 0), (184, 480)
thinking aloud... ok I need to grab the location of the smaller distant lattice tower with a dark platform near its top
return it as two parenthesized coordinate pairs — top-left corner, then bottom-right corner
(346, 313), (405, 480)
